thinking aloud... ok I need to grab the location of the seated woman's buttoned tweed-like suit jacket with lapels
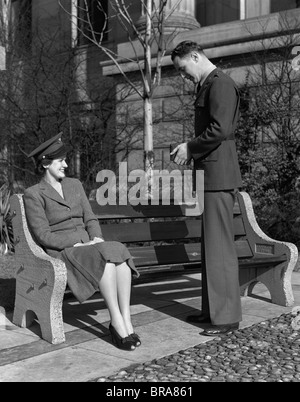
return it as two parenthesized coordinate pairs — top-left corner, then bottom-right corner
(24, 178), (102, 257)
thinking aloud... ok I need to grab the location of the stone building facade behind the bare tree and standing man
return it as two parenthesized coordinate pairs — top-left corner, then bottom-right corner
(1, 0), (300, 184)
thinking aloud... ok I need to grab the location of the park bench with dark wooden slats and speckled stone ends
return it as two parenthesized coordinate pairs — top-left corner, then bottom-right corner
(10, 192), (298, 344)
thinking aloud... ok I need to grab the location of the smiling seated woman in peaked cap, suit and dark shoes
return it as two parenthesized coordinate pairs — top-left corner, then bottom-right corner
(24, 133), (141, 350)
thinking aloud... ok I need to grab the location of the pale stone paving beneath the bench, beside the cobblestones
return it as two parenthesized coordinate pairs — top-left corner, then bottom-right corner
(0, 273), (300, 382)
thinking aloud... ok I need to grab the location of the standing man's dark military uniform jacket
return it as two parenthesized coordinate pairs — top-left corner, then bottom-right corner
(188, 68), (242, 191)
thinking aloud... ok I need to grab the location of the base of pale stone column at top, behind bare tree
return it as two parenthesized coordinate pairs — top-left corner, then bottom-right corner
(137, 0), (200, 35)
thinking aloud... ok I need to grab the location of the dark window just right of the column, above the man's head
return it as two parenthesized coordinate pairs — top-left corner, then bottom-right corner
(196, 0), (240, 27)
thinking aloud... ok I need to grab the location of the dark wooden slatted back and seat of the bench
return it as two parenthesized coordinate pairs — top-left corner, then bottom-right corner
(90, 194), (253, 269)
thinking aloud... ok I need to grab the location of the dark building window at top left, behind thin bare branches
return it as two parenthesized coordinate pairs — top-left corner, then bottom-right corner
(78, 0), (108, 45)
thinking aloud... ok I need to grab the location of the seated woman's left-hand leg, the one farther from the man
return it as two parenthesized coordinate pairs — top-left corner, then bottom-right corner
(99, 263), (129, 338)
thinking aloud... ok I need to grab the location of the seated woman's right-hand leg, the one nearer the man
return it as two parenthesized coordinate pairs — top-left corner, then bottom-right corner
(116, 262), (133, 334)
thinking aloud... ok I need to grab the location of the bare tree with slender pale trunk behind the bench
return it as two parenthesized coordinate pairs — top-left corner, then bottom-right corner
(60, 0), (182, 193)
